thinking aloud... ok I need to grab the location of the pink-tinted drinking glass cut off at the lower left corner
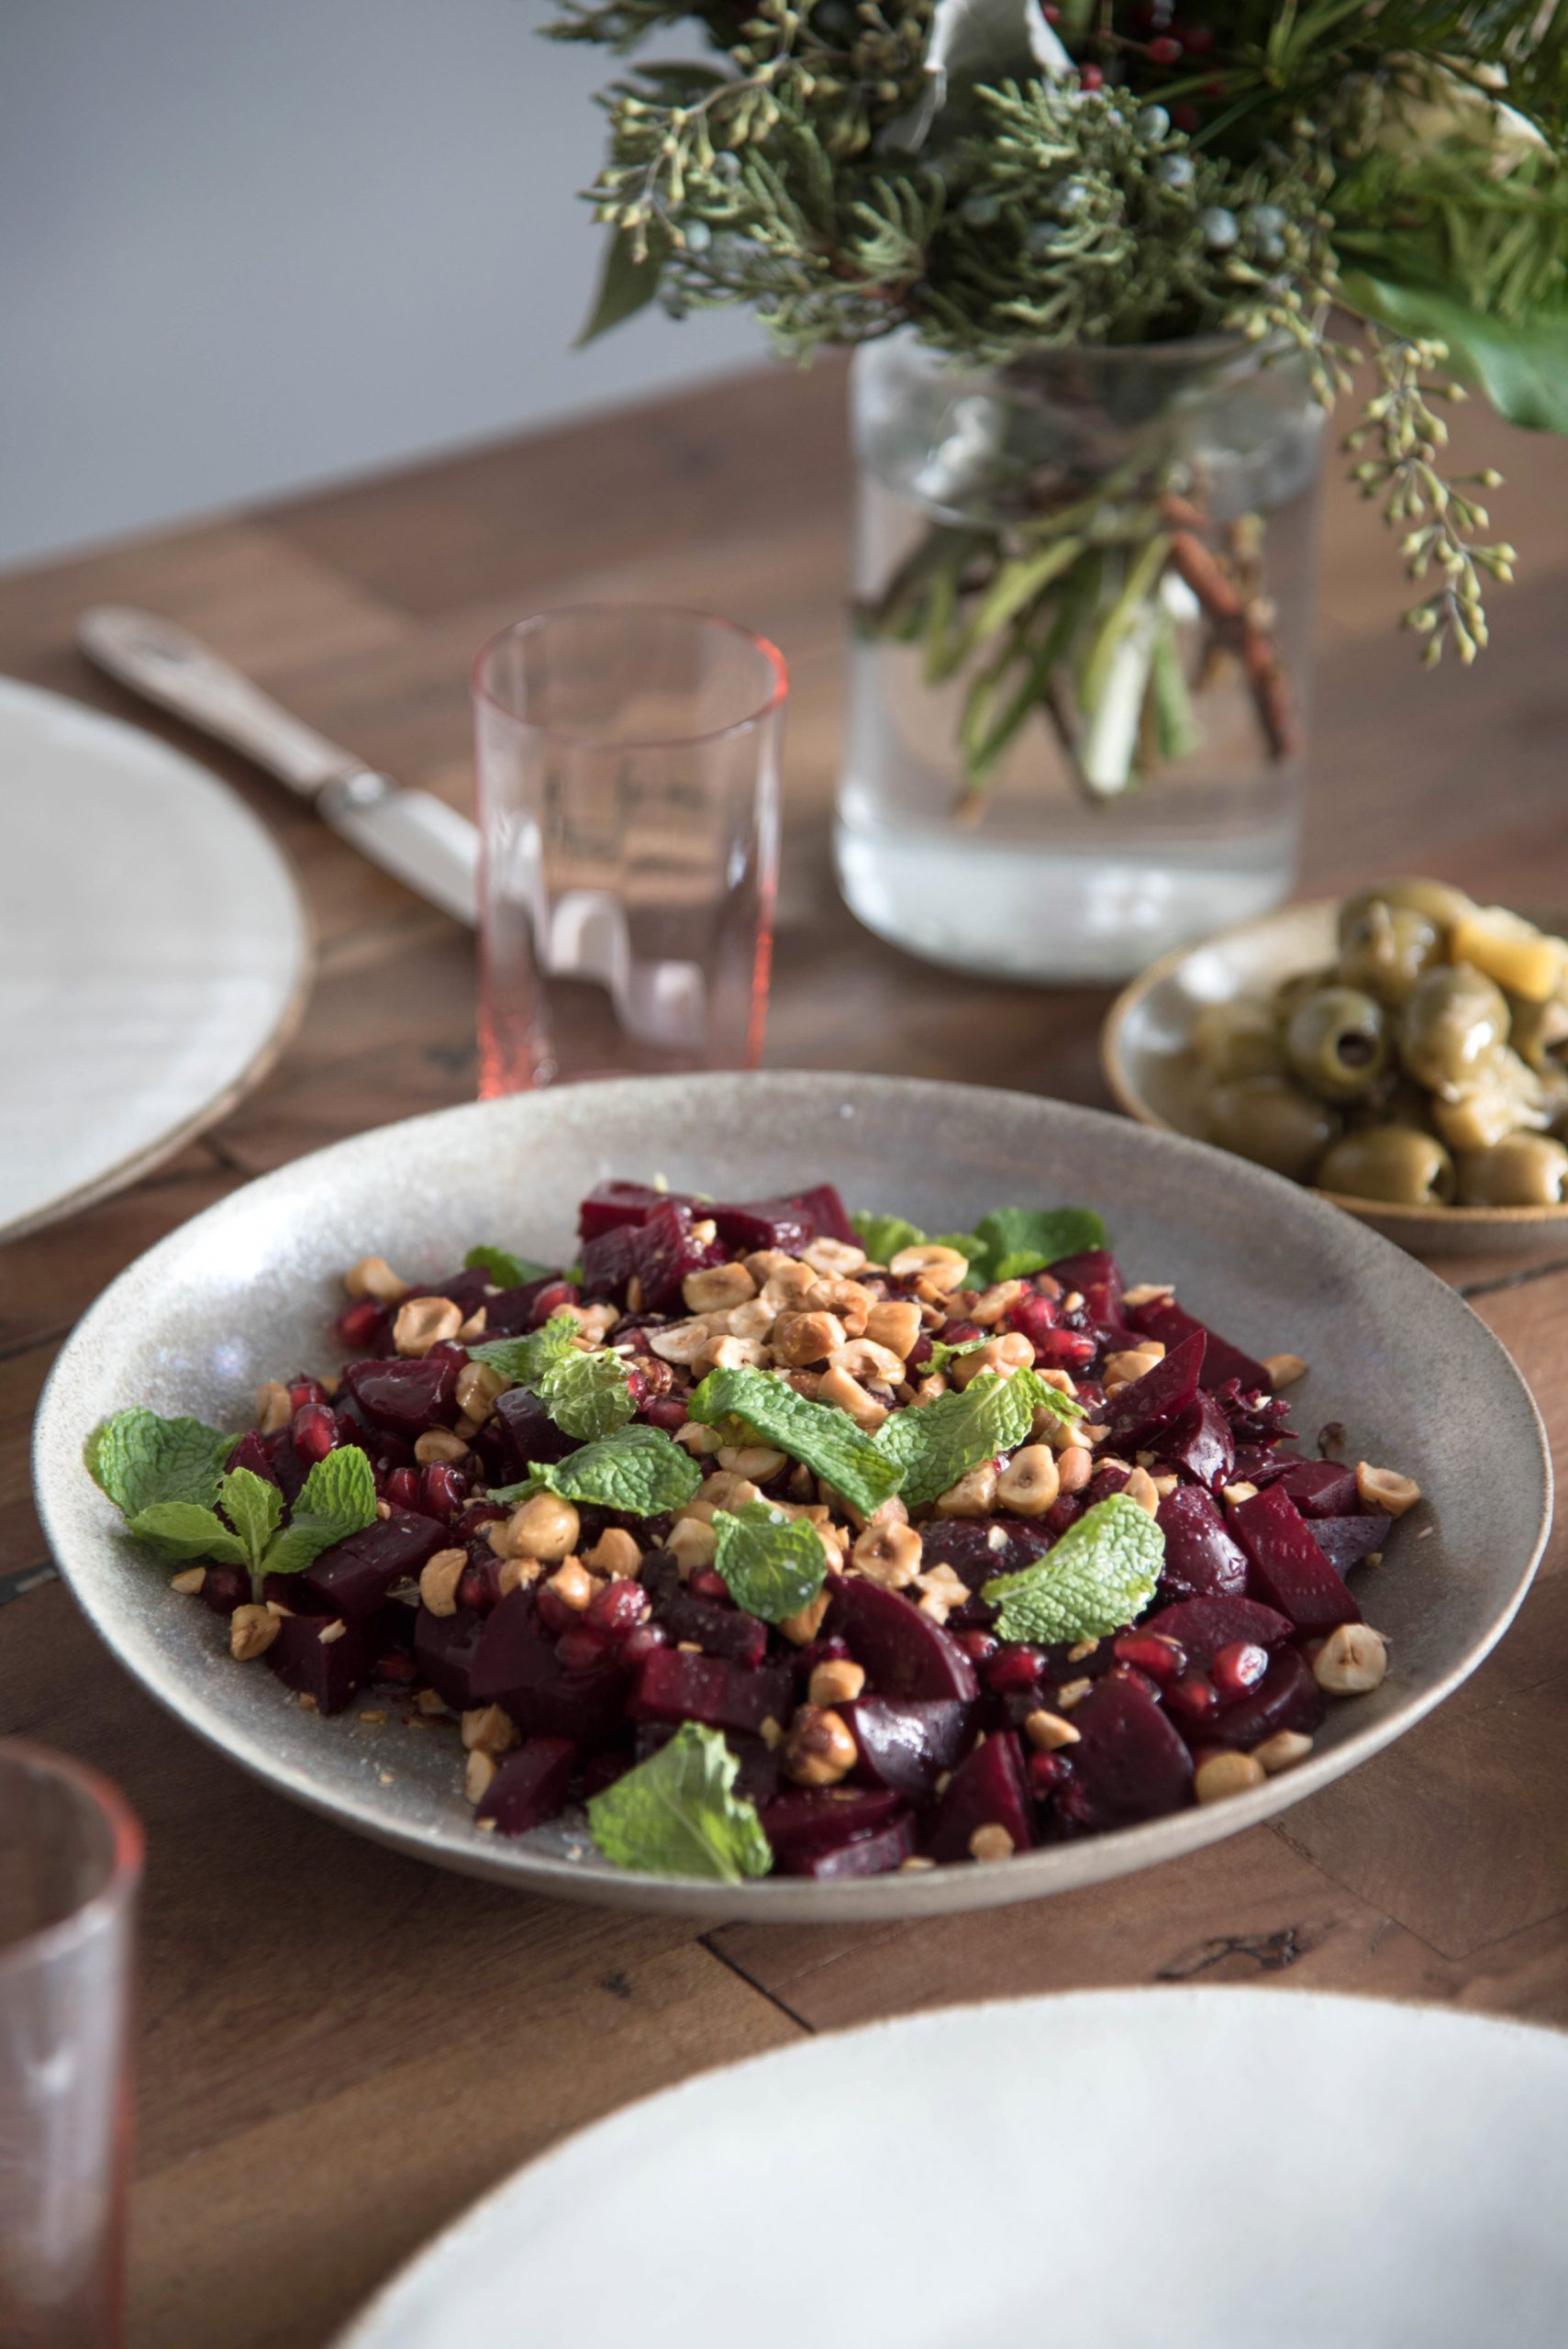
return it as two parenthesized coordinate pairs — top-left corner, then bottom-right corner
(0, 1738), (141, 2349)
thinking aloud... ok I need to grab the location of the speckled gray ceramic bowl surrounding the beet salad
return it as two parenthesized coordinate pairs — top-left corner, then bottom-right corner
(35, 1074), (1551, 1924)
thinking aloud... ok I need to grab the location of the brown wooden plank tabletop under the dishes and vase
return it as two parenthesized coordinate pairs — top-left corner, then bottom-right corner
(0, 366), (1568, 2349)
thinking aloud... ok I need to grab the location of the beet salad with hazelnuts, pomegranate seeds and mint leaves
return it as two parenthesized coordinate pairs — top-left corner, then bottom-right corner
(87, 1182), (1420, 1882)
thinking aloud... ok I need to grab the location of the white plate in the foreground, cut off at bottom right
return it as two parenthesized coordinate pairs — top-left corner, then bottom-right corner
(338, 1989), (1568, 2349)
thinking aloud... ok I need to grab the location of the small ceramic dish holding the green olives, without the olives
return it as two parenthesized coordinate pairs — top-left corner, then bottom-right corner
(1101, 897), (1568, 1257)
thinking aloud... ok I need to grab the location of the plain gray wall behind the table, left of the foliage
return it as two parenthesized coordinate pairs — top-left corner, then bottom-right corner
(0, 0), (761, 562)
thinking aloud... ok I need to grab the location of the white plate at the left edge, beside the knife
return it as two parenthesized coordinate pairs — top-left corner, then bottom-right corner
(0, 676), (310, 1238)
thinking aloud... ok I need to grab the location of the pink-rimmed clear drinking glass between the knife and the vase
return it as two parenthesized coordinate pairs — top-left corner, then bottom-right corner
(474, 604), (789, 1097)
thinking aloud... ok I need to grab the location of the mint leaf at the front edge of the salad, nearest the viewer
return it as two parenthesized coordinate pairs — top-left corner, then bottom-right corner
(587, 1721), (773, 1884)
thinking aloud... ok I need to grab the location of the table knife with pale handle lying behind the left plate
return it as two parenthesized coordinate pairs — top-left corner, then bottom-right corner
(77, 604), (479, 928)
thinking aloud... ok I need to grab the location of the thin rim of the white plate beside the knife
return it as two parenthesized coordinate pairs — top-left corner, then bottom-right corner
(0, 676), (315, 1242)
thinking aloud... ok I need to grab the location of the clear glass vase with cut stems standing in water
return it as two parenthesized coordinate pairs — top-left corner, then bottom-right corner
(838, 334), (1324, 980)
